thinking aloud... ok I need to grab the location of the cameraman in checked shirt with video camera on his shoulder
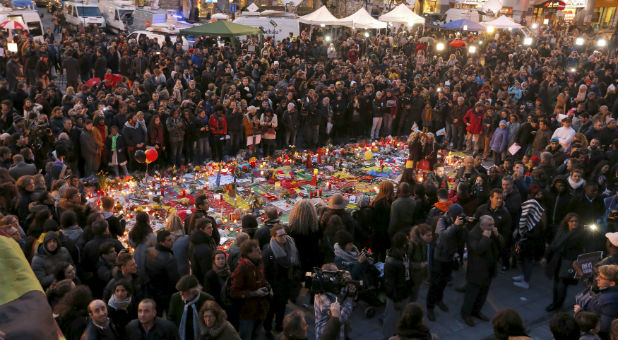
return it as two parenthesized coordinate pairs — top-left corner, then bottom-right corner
(312, 263), (356, 339)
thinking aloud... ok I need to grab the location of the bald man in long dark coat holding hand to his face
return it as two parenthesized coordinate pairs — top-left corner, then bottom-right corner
(461, 215), (504, 327)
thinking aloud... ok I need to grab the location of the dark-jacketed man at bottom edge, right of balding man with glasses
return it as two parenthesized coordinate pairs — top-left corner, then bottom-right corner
(125, 299), (178, 340)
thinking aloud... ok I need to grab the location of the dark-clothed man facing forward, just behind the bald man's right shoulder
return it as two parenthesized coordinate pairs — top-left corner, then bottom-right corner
(474, 189), (513, 268)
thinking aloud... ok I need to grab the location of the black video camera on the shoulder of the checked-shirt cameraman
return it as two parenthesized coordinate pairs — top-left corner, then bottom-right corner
(306, 268), (363, 301)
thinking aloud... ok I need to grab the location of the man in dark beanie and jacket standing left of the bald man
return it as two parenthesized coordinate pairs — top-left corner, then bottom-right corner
(427, 203), (465, 321)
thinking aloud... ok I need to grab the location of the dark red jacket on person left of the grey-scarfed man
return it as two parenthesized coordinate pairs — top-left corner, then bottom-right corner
(230, 257), (269, 320)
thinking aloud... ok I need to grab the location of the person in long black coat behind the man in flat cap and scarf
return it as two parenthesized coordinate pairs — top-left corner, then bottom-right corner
(146, 230), (179, 315)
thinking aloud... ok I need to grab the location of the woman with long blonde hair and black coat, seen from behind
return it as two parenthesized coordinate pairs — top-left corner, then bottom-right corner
(287, 199), (321, 273)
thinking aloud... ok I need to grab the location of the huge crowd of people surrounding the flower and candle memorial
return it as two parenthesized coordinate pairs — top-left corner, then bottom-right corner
(0, 5), (618, 340)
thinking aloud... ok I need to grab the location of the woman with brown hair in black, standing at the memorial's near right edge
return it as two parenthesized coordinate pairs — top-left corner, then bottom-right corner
(371, 181), (395, 261)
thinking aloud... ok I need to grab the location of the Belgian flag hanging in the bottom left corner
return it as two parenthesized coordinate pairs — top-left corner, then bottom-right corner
(0, 230), (62, 340)
